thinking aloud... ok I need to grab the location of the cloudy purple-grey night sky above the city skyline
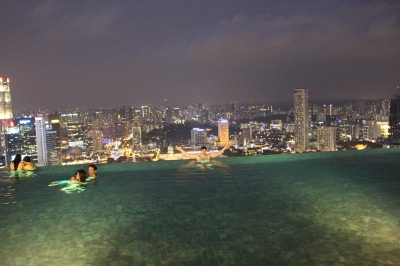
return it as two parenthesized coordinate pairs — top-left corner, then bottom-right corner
(0, 0), (400, 110)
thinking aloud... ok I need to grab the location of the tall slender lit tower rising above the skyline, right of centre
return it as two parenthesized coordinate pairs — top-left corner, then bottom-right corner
(294, 89), (310, 152)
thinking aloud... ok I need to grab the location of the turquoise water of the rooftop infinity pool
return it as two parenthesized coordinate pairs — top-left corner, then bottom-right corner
(0, 149), (400, 266)
